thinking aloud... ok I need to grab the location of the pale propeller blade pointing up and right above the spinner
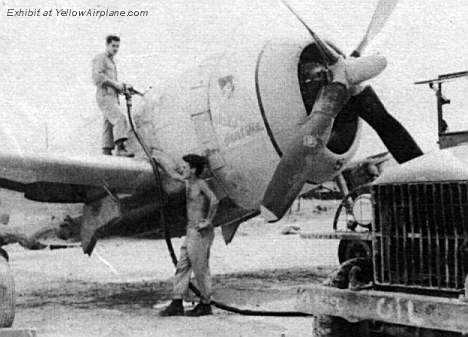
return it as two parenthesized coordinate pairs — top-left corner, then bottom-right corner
(351, 0), (398, 57)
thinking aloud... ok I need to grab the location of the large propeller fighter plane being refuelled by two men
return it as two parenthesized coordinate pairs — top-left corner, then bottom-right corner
(0, 0), (422, 253)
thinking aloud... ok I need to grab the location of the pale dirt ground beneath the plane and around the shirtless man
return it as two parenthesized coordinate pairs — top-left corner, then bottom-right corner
(3, 196), (344, 336)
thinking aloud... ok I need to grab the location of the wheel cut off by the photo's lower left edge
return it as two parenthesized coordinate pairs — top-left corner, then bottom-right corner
(0, 248), (16, 328)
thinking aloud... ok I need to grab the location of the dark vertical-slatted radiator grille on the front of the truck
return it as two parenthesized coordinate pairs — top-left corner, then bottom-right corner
(372, 181), (468, 292)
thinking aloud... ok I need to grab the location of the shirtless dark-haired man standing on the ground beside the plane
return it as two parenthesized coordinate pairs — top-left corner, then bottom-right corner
(159, 154), (218, 316)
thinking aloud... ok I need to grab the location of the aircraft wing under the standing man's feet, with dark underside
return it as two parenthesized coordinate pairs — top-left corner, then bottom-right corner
(0, 152), (153, 203)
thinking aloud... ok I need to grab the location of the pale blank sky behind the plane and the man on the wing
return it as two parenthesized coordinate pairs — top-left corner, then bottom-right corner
(0, 0), (468, 156)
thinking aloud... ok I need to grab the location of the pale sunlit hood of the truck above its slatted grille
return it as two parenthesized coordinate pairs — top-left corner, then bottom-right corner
(374, 144), (468, 184)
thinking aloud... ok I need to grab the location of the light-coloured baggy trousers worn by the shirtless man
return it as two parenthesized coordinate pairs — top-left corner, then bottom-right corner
(173, 226), (214, 303)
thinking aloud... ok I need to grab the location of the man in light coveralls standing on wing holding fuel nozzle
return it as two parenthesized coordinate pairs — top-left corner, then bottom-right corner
(92, 35), (133, 157)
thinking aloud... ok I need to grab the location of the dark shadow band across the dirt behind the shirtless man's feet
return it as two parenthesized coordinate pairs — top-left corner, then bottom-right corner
(17, 266), (333, 311)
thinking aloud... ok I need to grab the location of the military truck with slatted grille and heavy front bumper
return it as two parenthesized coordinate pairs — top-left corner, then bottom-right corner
(297, 71), (468, 336)
